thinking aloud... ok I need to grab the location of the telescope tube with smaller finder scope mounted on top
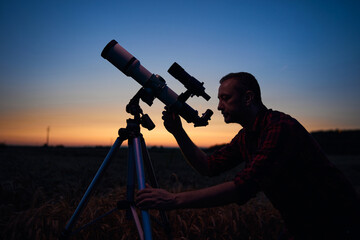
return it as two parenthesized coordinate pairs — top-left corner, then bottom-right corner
(101, 40), (213, 127)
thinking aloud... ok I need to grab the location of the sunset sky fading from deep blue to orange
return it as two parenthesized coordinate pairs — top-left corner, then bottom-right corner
(0, 0), (360, 147)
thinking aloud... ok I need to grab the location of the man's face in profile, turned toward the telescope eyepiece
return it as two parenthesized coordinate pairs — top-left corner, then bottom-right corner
(218, 79), (245, 124)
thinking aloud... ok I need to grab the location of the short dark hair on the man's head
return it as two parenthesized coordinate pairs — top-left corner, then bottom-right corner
(220, 72), (262, 104)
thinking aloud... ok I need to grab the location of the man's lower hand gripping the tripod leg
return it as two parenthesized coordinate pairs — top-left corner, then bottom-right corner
(135, 184), (176, 210)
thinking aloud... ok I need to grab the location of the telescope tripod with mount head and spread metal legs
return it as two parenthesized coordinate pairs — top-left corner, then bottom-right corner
(60, 93), (171, 240)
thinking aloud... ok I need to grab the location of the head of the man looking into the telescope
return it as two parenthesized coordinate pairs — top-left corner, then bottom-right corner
(218, 72), (264, 127)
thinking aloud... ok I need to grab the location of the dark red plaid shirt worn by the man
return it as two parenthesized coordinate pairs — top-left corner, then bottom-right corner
(208, 109), (358, 239)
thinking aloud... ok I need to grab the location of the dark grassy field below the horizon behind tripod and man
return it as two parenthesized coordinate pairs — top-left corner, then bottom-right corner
(0, 146), (360, 240)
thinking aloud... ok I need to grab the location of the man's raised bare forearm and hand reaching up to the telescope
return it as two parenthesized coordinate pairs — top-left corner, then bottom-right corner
(162, 110), (210, 175)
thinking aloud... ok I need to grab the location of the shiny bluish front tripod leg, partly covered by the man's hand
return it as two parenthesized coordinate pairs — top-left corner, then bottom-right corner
(129, 137), (152, 240)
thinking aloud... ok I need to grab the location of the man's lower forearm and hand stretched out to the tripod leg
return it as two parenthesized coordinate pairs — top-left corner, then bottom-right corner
(136, 181), (239, 210)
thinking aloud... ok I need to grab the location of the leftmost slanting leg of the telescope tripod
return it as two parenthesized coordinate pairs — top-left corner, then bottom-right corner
(62, 137), (124, 239)
